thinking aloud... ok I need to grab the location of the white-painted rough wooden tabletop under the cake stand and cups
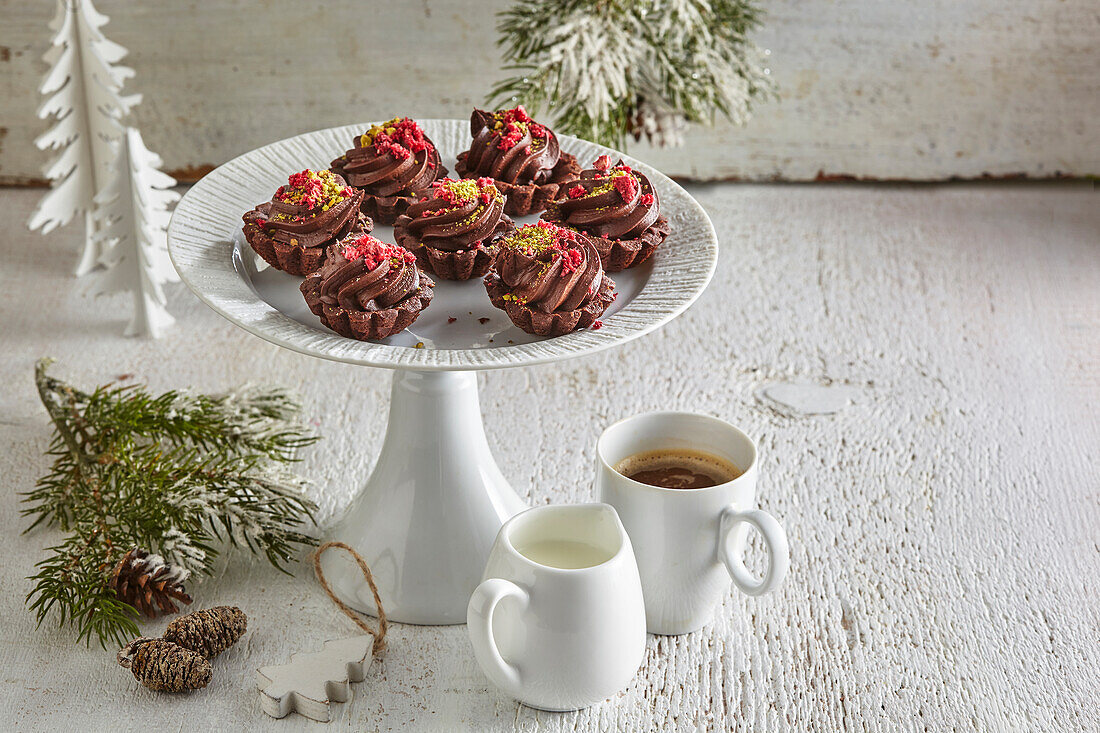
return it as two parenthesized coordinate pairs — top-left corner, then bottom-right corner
(0, 184), (1100, 731)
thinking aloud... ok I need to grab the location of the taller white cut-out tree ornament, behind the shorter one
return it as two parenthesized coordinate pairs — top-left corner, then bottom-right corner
(28, 0), (141, 275)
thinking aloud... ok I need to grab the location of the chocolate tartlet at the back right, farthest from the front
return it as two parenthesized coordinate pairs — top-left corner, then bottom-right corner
(454, 106), (581, 217)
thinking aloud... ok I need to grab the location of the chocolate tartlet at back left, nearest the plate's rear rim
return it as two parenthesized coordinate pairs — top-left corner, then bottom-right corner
(332, 117), (447, 225)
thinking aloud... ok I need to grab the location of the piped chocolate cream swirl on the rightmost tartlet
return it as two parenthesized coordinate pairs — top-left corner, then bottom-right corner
(542, 156), (661, 239)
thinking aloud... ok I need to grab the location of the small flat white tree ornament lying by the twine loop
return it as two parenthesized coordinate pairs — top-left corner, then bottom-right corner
(256, 634), (374, 723)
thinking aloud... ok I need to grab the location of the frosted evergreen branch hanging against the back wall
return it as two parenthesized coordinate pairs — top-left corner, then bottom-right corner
(491, 0), (773, 147)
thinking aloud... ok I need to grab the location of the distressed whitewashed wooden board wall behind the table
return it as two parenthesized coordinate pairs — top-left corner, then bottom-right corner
(0, 0), (1100, 183)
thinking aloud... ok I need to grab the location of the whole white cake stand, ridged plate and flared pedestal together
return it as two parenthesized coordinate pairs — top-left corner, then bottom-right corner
(168, 120), (718, 624)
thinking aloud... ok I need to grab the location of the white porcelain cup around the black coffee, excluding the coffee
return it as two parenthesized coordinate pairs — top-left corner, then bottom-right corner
(596, 412), (790, 634)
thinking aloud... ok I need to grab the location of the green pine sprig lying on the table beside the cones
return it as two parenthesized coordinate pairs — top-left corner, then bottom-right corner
(22, 359), (317, 646)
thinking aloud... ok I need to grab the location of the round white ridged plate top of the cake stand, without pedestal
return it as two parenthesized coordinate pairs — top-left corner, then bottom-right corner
(162, 120), (718, 371)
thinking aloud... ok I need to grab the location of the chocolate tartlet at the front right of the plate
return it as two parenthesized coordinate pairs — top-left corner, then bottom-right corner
(485, 221), (615, 336)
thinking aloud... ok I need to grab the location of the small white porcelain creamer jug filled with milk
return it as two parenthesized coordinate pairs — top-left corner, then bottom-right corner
(466, 504), (646, 711)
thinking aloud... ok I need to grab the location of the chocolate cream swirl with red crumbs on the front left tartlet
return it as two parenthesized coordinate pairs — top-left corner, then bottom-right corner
(318, 234), (420, 310)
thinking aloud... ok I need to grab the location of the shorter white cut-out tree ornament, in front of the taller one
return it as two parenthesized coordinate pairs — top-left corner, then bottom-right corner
(92, 128), (179, 338)
